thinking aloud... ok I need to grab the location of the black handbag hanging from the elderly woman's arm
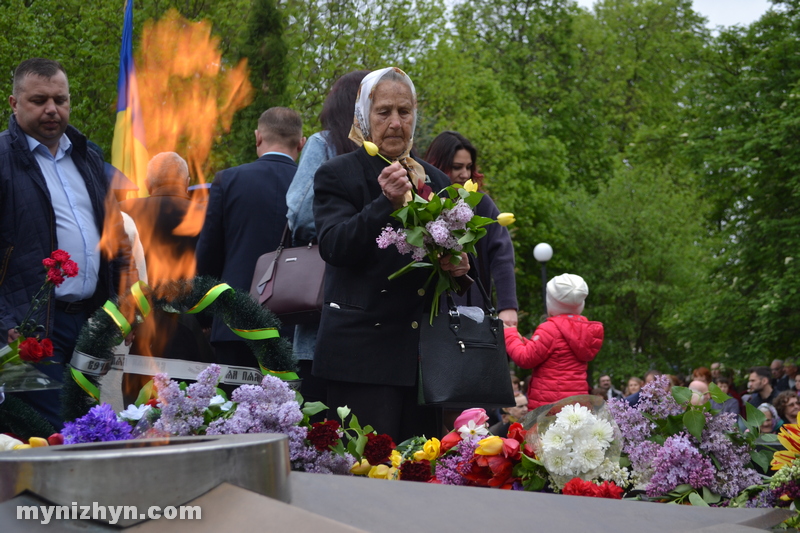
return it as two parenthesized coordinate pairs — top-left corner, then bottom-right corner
(419, 277), (515, 409)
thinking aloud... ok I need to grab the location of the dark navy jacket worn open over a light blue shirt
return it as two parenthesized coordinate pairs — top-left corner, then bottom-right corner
(0, 115), (135, 345)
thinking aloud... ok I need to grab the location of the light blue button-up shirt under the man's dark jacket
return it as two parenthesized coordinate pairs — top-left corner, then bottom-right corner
(25, 134), (100, 302)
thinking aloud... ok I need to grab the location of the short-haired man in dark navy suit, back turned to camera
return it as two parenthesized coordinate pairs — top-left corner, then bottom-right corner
(197, 107), (305, 367)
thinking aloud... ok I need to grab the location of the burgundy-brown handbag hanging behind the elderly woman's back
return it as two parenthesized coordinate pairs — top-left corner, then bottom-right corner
(250, 224), (325, 325)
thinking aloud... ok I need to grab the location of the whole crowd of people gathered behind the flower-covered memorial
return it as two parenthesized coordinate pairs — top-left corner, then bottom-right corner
(0, 59), (800, 442)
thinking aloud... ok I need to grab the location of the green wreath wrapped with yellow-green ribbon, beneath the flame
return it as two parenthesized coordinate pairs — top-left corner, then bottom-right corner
(61, 276), (297, 421)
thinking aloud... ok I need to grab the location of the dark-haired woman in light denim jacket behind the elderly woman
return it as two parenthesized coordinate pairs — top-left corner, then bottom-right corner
(286, 70), (369, 408)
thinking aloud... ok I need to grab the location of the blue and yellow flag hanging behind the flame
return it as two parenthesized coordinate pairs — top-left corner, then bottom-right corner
(111, 0), (150, 196)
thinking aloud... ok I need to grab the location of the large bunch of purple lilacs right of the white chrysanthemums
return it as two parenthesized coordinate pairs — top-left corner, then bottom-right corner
(608, 376), (769, 505)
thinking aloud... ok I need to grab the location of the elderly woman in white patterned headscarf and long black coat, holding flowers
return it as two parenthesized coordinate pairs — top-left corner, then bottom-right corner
(312, 68), (469, 442)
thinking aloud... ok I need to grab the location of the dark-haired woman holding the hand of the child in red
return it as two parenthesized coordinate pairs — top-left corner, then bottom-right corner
(425, 131), (518, 326)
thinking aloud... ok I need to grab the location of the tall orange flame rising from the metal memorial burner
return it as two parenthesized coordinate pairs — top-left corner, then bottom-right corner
(101, 9), (253, 382)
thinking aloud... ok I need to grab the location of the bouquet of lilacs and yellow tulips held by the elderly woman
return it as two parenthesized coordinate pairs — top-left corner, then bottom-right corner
(376, 180), (514, 323)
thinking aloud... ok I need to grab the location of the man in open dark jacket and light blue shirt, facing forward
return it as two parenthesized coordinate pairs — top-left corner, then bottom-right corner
(0, 59), (135, 429)
